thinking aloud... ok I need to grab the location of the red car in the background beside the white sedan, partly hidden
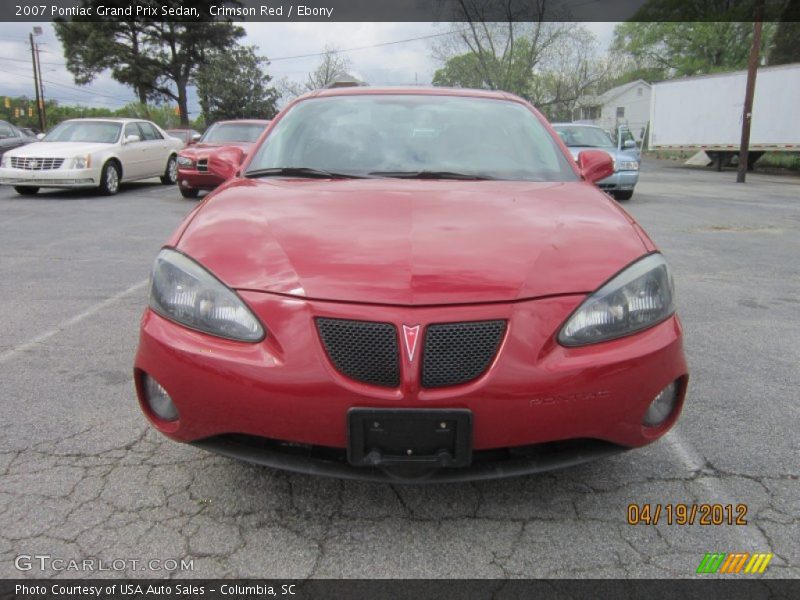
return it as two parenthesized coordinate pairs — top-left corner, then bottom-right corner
(178, 119), (270, 198)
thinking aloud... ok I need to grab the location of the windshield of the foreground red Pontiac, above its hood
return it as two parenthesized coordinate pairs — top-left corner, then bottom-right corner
(247, 94), (577, 181)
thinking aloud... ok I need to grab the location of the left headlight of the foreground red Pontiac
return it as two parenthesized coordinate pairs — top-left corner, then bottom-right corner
(150, 249), (264, 342)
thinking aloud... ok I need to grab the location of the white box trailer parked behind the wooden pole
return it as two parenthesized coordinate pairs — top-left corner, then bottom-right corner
(649, 63), (800, 168)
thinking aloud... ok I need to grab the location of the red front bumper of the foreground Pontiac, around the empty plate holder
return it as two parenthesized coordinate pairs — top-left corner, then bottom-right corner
(135, 291), (687, 480)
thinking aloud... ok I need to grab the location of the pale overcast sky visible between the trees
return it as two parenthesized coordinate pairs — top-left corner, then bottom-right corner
(0, 22), (615, 118)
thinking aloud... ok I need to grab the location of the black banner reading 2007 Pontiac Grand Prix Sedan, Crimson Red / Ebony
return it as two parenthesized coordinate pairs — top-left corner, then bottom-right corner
(0, 0), (800, 22)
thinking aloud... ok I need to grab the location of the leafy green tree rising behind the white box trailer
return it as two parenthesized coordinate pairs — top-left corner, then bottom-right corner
(611, 21), (774, 79)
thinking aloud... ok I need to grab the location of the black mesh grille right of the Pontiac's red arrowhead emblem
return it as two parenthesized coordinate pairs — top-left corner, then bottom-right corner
(422, 320), (506, 388)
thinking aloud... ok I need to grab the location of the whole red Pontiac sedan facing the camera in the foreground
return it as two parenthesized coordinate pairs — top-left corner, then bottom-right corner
(135, 88), (688, 481)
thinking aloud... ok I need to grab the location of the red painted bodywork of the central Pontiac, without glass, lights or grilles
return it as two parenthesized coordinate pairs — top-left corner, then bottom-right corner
(135, 88), (688, 481)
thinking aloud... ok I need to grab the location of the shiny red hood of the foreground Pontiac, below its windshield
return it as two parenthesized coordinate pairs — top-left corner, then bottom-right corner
(177, 179), (646, 305)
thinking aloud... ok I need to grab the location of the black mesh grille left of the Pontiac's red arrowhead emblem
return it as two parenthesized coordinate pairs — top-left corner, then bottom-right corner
(316, 318), (400, 387)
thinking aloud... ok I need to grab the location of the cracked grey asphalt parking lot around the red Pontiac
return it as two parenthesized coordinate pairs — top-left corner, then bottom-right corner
(0, 161), (800, 578)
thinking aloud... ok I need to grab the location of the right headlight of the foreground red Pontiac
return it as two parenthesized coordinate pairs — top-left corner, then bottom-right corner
(558, 254), (675, 346)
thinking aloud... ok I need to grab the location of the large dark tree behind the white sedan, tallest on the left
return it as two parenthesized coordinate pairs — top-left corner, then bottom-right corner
(55, 0), (244, 124)
